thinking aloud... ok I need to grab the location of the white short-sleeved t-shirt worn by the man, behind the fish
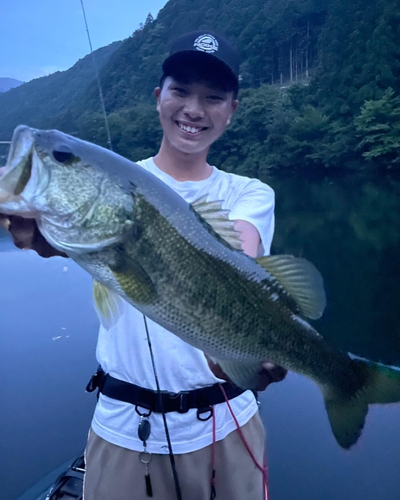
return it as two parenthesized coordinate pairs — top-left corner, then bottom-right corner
(92, 158), (274, 454)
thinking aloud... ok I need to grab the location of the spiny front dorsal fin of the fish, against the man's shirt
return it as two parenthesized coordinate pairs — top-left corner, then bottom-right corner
(191, 195), (242, 250)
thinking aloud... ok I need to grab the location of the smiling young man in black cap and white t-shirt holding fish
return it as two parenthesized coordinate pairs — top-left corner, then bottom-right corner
(0, 31), (285, 500)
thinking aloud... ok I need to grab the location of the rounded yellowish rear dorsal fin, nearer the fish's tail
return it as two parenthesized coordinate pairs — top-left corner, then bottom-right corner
(256, 255), (326, 319)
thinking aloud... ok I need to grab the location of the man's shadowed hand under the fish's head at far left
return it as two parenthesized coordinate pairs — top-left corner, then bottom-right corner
(0, 168), (68, 257)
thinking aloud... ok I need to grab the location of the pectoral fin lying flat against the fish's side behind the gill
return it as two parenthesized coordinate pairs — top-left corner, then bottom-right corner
(110, 253), (158, 305)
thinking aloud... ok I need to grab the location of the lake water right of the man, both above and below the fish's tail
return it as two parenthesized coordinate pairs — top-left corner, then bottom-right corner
(261, 173), (400, 500)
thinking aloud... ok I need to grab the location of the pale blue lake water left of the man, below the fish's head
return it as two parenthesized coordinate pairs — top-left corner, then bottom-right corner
(0, 240), (98, 500)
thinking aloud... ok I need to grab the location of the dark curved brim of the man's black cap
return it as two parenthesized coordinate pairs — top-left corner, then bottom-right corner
(160, 57), (239, 99)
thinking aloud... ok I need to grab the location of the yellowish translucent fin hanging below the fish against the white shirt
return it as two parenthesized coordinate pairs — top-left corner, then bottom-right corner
(93, 280), (124, 330)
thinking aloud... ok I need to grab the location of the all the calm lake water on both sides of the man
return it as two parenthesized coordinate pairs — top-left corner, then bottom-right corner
(0, 174), (400, 500)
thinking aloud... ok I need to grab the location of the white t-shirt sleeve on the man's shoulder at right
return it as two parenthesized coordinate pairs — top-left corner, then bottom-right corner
(229, 179), (275, 255)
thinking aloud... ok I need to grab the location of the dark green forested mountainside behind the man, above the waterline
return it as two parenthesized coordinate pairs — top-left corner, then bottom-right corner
(0, 0), (400, 175)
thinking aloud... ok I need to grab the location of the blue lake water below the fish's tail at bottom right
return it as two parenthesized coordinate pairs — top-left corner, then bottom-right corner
(261, 374), (400, 500)
